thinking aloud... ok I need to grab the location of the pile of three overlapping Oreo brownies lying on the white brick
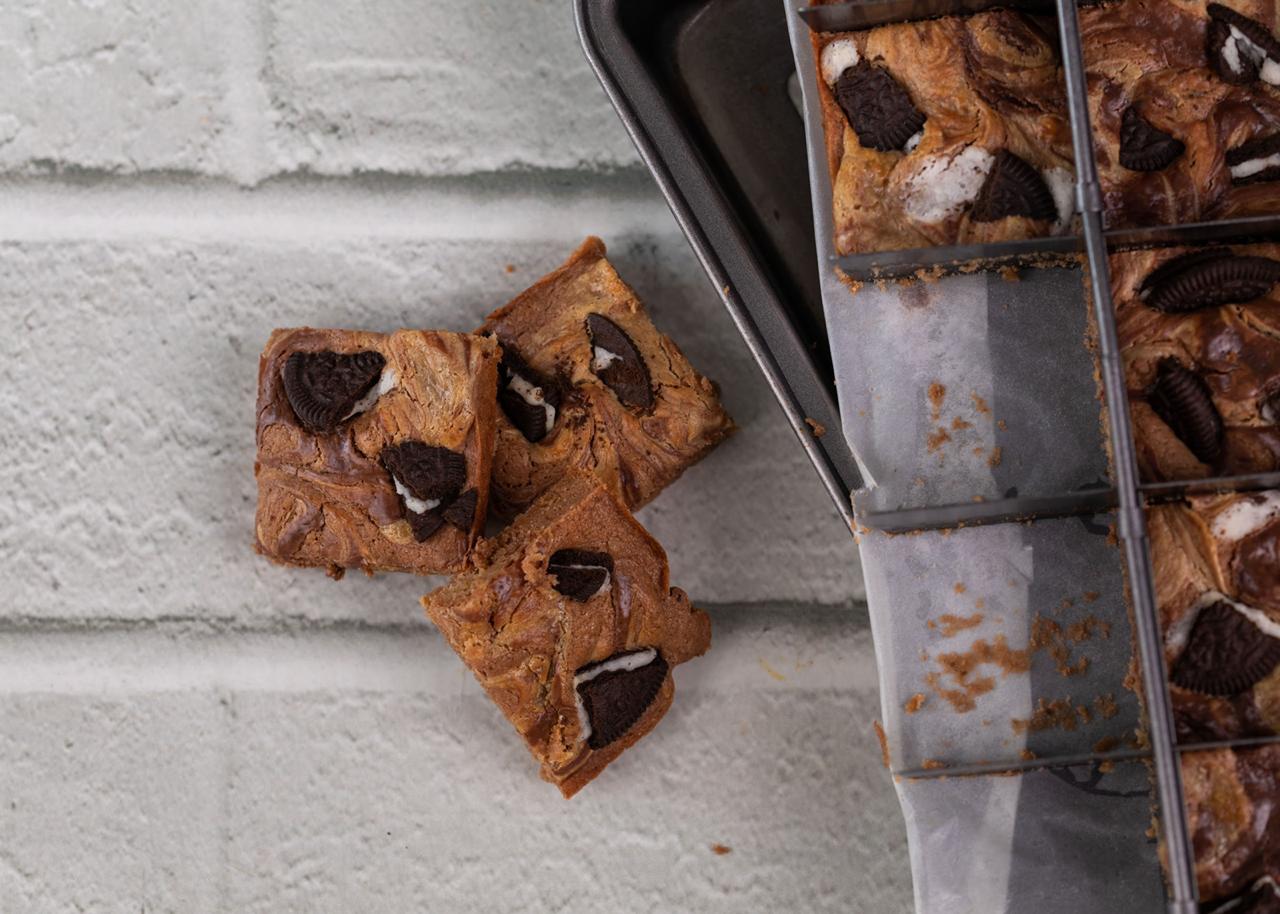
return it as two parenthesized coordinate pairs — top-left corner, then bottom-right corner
(255, 238), (733, 796)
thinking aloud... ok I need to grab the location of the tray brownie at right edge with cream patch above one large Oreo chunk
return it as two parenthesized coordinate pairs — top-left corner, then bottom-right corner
(1147, 492), (1280, 742)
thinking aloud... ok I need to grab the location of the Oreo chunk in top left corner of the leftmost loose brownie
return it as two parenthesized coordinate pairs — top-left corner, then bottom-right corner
(288, 349), (387, 434)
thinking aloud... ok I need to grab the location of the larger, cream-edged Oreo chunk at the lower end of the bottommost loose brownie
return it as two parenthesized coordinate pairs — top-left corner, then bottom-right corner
(573, 648), (668, 749)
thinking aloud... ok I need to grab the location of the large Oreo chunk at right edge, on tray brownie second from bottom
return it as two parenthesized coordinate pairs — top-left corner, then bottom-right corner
(1170, 600), (1280, 696)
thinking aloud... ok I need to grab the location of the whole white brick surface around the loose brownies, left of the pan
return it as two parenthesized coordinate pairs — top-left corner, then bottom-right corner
(0, 0), (909, 913)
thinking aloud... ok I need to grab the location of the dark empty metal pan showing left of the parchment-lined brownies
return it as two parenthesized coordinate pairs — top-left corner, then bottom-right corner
(575, 0), (861, 527)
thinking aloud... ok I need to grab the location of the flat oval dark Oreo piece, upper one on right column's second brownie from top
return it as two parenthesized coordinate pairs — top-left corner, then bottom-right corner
(1138, 248), (1280, 314)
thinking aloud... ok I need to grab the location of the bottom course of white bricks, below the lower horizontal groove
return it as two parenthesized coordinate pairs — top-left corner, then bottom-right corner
(0, 609), (909, 914)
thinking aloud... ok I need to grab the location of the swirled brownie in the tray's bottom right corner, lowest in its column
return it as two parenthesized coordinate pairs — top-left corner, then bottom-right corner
(1183, 744), (1280, 914)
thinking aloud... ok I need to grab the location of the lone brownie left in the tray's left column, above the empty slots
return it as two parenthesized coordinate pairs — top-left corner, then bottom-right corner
(814, 10), (1075, 253)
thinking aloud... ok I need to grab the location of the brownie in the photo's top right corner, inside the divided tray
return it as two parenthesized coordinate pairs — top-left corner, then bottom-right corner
(1080, 0), (1280, 228)
